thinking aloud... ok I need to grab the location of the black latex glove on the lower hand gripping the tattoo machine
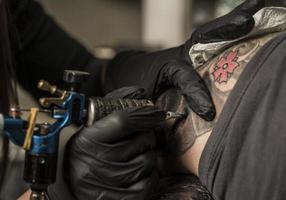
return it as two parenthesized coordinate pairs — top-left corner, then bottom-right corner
(64, 88), (165, 200)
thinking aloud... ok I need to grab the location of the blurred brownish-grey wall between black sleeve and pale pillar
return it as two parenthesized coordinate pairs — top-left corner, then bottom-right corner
(38, 0), (142, 48)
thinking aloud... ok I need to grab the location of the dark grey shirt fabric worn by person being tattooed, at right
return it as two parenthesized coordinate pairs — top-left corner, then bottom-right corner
(199, 34), (286, 200)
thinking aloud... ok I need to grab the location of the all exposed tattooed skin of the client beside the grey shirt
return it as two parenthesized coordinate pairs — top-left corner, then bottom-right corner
(156, 31), (277, 174)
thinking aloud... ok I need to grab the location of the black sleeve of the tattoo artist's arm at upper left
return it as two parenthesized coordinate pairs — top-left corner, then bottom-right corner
(10, 0), (101, 96)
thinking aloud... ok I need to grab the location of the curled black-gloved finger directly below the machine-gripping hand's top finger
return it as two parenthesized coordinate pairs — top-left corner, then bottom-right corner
(78, 131), (156, 162)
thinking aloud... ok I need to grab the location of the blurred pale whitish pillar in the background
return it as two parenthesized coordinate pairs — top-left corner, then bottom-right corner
(142, 0), (192, 48)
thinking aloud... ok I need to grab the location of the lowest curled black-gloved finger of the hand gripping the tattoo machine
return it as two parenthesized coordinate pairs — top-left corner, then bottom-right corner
(67, 149), (156, 187)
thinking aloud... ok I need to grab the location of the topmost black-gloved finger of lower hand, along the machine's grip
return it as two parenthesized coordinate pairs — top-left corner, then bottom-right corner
(79, 106), (166, 145)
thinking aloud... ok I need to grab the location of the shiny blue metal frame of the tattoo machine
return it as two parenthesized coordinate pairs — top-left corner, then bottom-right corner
(0, 92), (85, 154)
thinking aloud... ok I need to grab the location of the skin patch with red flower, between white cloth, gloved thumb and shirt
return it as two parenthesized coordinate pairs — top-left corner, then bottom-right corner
(198, 34), (277, 118)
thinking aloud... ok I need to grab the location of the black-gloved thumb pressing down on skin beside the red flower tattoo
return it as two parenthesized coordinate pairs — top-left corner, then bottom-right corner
(165, 60), (216, 121)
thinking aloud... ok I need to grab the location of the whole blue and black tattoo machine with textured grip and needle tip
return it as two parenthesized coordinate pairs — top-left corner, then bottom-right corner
(0, 70), (184, 200)
